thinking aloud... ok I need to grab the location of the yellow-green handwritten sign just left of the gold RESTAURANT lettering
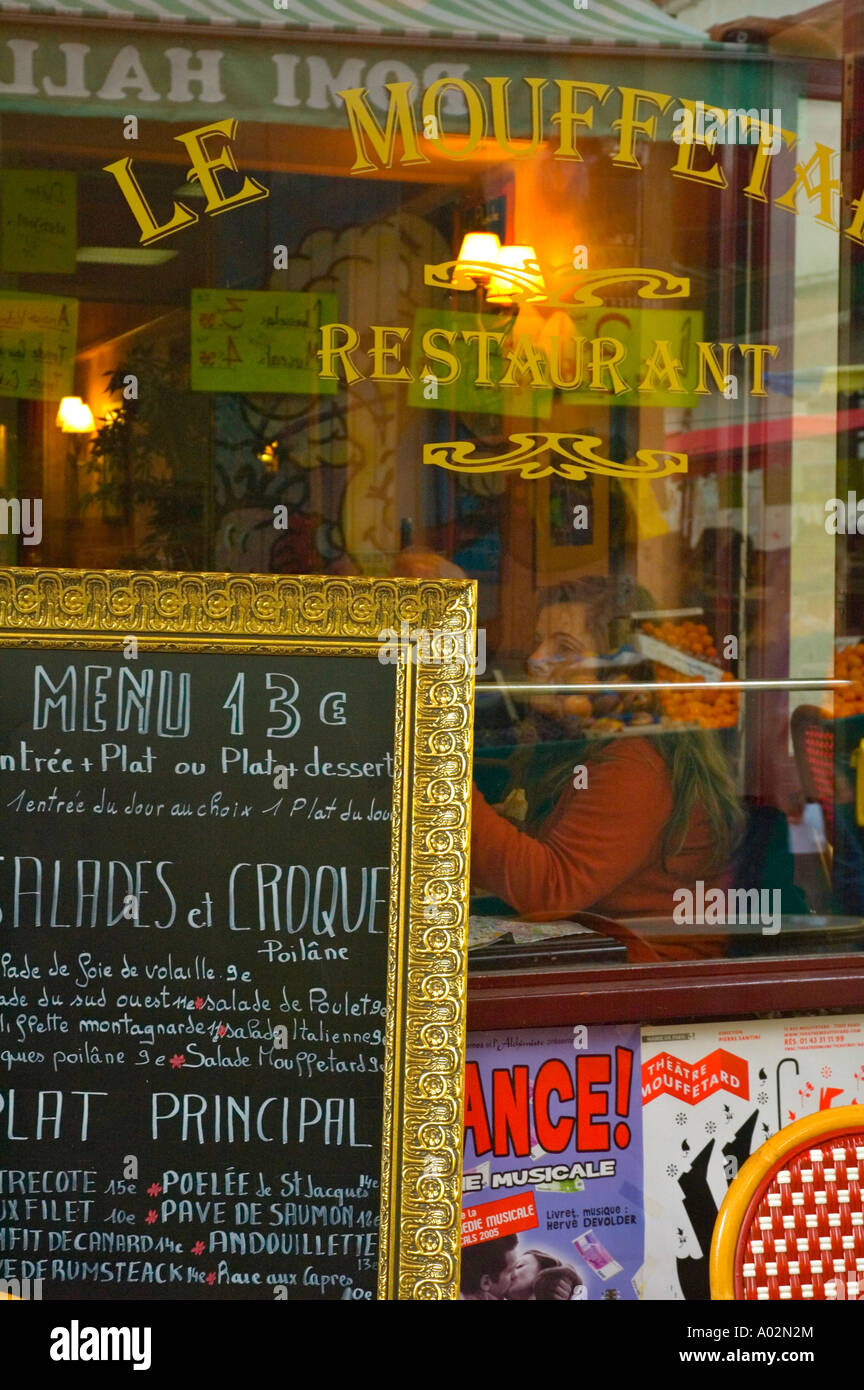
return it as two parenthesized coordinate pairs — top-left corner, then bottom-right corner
(190, 289), (339, 395)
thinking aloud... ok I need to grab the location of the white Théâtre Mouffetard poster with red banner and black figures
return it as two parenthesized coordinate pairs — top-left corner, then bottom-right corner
(642, 1016), (864, 1301)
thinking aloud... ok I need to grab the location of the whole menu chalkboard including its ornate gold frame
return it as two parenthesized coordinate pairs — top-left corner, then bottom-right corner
(0, 570), (475, 1301)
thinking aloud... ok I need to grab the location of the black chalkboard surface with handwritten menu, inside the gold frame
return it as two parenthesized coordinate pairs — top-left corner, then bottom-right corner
(0, 641), (396, 1300)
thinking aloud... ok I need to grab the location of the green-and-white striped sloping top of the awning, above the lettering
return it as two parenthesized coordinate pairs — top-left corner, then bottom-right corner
(0, 0), (722, 49)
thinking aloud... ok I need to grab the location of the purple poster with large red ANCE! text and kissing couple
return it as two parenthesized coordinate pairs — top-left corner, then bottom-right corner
(461, 1024), (643, 1302)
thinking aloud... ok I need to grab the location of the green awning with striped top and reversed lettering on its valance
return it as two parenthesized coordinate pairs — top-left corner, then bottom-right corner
(0, 0), (781, 129)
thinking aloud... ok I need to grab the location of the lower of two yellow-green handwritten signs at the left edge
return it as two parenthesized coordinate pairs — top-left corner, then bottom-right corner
(0, 289), (78, 400)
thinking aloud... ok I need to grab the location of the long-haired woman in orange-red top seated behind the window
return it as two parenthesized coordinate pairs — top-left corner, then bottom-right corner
(471, 577), (743, 956)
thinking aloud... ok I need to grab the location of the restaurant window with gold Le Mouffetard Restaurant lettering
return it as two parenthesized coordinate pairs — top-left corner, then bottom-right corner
(0, 0), (864, 959)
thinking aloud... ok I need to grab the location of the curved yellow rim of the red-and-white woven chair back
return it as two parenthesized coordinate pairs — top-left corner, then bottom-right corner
(710, 1105), (864, 1301)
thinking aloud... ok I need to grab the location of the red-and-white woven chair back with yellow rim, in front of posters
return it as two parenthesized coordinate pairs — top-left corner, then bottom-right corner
(711, 1105), (864, 1301)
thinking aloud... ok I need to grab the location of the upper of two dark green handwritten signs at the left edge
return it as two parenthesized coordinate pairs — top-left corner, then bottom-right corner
(0, 170), (78, 275)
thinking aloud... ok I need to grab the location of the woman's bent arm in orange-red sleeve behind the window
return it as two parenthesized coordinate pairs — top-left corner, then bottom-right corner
(471, 739), (672, 917)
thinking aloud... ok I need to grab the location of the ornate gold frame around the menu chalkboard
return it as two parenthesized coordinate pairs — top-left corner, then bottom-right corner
(0, 569), (476, 1300)
